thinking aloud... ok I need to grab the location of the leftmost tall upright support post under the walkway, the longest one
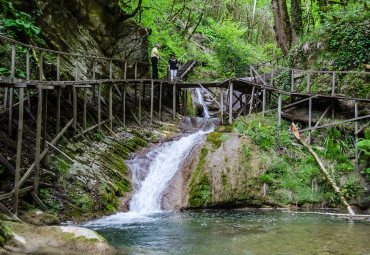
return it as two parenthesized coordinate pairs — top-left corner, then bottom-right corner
(13, 88), (24, 215)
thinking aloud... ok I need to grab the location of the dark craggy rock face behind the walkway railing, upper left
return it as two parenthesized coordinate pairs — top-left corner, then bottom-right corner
(23, 0), (150, 79)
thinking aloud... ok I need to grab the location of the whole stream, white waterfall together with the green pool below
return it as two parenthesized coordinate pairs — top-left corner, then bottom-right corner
(84, 89), (370, 255)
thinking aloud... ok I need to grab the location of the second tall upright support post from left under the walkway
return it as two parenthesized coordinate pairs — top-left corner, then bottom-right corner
(33, 89), (43, 197)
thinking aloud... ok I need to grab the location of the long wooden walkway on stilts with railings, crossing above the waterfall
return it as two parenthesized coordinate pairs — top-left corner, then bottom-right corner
(0, 36), (370, 220)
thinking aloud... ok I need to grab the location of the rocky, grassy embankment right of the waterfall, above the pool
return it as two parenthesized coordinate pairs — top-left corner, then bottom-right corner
(181, 116), (369, 210)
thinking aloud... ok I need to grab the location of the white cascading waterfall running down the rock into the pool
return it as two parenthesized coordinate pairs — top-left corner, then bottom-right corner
(87, 91), (213, 226)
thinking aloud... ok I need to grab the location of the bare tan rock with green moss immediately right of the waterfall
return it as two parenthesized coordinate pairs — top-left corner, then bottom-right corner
(162, 132), (263, 209)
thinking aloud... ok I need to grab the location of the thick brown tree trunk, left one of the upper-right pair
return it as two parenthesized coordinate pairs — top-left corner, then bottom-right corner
(271, 0), (292, 55)
